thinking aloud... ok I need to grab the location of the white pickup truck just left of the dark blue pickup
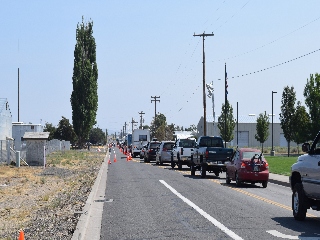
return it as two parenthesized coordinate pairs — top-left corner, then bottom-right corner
(171, 138), (196, 170)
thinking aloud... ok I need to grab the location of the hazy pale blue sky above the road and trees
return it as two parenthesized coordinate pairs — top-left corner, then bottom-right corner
(0, 0), (320, 132)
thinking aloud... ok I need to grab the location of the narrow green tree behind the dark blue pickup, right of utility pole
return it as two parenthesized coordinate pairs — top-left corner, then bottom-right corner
(218, 101), (236, 142)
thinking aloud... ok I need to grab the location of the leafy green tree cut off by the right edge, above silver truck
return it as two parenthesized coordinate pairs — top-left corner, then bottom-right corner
(303, 73), (320, 139)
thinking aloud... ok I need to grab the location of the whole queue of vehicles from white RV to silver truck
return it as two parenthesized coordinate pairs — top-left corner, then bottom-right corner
(112, 129), (320, 221)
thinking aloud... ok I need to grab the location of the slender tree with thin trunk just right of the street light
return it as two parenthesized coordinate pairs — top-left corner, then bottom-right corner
(279, 86), (296, 157)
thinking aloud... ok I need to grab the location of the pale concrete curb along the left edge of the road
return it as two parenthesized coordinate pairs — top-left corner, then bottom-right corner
(71, 153), (110, 240)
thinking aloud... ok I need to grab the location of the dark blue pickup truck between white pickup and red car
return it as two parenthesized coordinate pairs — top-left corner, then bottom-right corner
(191, 136), (233, 178)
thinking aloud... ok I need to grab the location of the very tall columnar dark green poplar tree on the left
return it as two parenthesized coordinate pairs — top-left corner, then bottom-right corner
(70, 17), (98, 147)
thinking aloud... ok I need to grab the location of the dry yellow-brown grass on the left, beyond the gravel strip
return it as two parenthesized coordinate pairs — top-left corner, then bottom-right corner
(0, 150), (106, 240)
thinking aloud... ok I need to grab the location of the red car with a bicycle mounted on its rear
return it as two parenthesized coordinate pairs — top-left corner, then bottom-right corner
(226, 148), (269, 188)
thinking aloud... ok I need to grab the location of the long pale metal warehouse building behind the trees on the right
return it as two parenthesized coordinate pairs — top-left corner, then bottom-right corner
(197, 114), (296, 147)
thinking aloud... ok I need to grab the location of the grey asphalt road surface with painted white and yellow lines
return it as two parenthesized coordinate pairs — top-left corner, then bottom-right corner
(101, 148), (320, 240)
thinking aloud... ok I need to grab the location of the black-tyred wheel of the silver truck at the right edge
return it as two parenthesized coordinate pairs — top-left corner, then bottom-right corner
(292, 183), (308, 221)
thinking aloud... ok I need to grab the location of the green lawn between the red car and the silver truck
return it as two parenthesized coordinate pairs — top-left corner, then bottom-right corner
(265, 155), (298, 176)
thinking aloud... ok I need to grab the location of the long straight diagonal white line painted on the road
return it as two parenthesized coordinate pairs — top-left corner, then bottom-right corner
(159, 180), (243, 240)
